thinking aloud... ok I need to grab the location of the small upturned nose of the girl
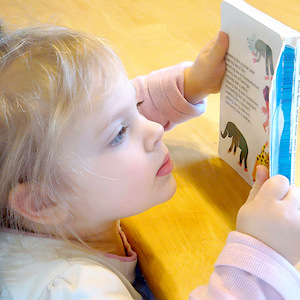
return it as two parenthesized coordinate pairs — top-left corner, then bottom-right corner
(144, 118), (164, 152)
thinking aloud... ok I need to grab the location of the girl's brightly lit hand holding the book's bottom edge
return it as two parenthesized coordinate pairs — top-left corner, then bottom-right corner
(236, 166), (300, 265)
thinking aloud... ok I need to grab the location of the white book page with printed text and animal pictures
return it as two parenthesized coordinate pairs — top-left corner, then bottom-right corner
(219, 1), (296, 186)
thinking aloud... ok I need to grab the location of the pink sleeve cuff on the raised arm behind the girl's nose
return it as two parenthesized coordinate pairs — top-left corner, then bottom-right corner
(131, 62), (206, 130)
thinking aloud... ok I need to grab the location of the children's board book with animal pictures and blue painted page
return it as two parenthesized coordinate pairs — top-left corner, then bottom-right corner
(219, 0), (300, 186)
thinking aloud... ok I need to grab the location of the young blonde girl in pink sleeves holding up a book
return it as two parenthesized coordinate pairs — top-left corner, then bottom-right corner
(0, 22), (300, 300)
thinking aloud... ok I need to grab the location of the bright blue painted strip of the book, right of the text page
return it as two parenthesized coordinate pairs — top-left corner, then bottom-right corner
(270, 45), (296, 184)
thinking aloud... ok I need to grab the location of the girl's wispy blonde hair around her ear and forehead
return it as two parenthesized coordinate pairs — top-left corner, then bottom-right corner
(0, 26), (124, 236)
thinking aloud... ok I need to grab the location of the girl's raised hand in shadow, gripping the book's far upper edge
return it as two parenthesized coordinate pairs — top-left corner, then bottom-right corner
(184, 31), (229, 104)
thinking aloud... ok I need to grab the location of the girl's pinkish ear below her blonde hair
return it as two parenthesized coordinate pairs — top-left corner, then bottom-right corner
(9, 183), (68, 225)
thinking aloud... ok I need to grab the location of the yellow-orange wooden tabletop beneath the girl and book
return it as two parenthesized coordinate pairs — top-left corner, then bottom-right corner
(0, 0), (300, 300)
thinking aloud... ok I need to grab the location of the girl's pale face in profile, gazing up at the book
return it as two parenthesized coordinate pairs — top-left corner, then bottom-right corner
(66, 74), (176, 230)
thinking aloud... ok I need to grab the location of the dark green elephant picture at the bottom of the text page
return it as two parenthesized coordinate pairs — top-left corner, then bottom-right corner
(221, 122), (248, 172)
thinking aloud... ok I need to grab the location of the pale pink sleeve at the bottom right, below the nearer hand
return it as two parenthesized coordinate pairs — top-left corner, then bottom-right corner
(190, 231), (300, 300)
